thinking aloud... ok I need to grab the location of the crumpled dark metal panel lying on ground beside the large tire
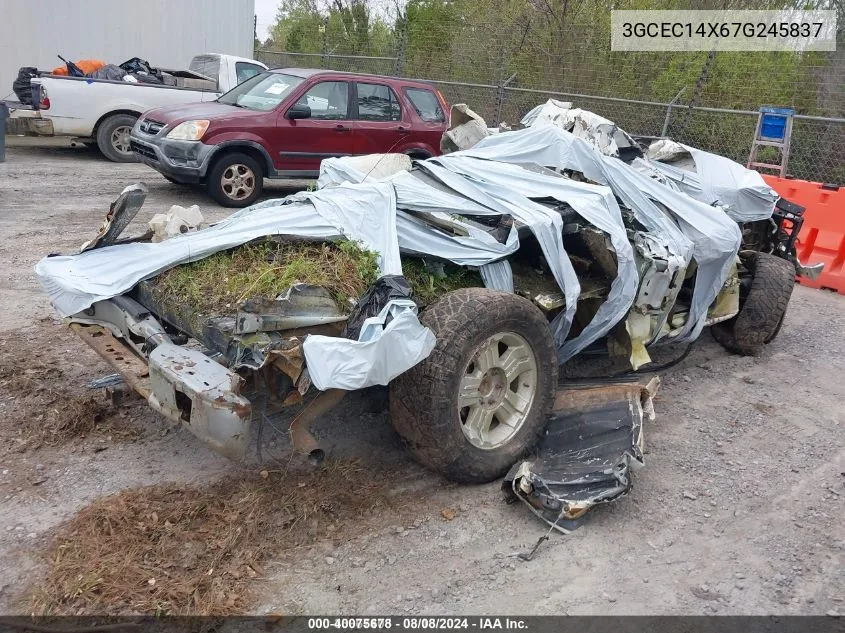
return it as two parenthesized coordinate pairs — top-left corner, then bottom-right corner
(502, 378), (660, 533)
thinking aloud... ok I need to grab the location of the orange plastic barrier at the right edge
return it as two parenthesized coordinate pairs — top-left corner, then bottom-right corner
(763, 175), (845, 295)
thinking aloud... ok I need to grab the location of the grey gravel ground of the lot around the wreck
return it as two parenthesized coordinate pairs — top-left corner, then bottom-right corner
(0, 141), (845, 614)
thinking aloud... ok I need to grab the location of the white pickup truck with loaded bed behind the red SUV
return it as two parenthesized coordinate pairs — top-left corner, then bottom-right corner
(7, 53), (267, 163)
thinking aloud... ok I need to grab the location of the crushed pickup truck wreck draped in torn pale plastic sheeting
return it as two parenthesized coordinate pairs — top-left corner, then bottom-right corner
(36, 103), (814, 482)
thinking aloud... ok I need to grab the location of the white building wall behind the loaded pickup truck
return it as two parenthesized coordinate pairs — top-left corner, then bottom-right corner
(0, 0), (255, 99)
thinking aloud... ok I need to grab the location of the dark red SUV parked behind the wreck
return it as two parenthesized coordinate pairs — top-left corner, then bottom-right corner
(131, 68), (448, 207)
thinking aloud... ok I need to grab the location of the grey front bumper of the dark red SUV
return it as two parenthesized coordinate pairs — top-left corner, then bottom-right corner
(129, 131), (214, 184)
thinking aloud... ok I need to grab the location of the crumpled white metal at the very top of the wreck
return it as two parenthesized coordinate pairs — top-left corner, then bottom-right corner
(520, 99), (642, 160)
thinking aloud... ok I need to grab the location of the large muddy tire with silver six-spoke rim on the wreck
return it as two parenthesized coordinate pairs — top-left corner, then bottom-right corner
(390, 288), (558, 483)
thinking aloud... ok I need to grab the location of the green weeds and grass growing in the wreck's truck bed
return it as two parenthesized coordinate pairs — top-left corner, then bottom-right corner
(152, 239), (379, 314)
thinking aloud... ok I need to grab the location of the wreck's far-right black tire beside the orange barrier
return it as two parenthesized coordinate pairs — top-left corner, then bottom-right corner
(710, 253), (795, 356)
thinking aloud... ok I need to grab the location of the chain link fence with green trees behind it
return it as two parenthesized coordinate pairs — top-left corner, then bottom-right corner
(256, 0), (845, 183)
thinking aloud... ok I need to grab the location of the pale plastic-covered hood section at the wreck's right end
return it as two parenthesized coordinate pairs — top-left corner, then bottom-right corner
(634, 139), (779, 222)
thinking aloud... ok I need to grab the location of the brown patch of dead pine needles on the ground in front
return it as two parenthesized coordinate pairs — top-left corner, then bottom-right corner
(32, 462), (420, 615)
